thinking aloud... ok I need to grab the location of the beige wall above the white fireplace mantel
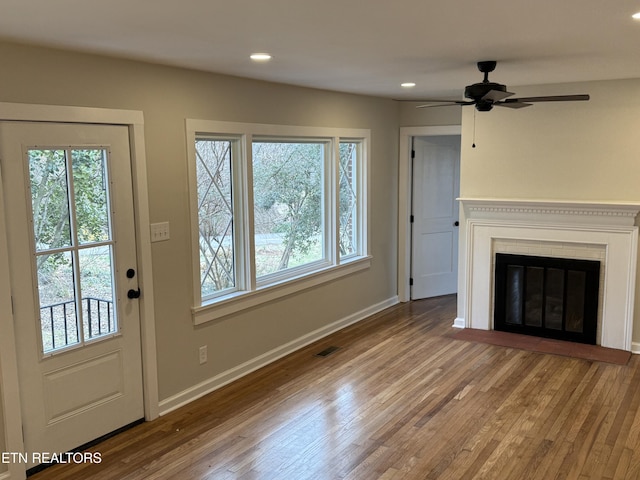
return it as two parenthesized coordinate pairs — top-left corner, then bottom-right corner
(460, 79), (640, 342)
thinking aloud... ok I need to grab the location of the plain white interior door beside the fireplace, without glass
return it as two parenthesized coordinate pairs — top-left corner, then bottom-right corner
(411, 135), (460, 299)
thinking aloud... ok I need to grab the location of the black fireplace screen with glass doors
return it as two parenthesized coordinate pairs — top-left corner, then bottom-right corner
(493, 253), (600, 345)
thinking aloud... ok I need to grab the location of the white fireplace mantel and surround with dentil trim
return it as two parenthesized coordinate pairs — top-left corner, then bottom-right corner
(456, 198), (640, 351)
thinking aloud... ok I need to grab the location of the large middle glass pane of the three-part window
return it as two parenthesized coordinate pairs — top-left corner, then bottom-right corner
(253, 142), (326, 277)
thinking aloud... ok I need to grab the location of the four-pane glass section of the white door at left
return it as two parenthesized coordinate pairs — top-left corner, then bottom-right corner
(28, 148), (118, 354)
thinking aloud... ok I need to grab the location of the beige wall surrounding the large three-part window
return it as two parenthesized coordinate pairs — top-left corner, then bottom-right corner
(0, 39), (398, 408)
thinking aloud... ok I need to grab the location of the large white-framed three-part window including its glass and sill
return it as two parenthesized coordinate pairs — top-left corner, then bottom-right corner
(187, 120), (369, 323)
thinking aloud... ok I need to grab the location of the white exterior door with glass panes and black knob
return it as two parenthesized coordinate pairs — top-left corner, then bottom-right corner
(0, 122), (144, 468)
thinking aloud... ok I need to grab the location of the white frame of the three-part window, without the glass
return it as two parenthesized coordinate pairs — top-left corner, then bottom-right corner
(186, 119), (372, 325)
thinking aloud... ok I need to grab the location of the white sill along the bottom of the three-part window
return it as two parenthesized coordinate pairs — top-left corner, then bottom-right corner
(191, 256), (371, 325)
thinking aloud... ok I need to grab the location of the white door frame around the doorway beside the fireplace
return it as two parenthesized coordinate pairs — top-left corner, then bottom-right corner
(398, 125), (462, 302)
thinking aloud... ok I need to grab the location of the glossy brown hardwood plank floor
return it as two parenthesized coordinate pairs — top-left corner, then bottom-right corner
(31, 296), (640, 480)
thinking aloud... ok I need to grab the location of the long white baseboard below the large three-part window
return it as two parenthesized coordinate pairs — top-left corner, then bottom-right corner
(157, 296), (399, 414)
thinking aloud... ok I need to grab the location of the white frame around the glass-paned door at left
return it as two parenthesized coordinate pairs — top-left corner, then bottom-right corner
(0, 102), (159, 480)
